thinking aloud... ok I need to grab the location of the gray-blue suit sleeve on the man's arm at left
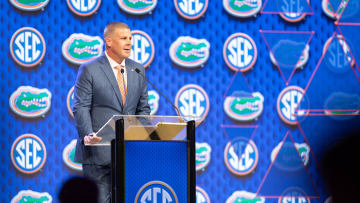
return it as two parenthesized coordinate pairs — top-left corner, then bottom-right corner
(73, 65), (93, 140)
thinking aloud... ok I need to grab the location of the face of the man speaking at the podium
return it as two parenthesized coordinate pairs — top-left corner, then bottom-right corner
(106, 28), (132, 63)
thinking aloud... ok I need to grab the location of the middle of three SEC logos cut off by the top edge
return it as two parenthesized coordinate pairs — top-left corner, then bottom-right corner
(174, 0), (209, 20)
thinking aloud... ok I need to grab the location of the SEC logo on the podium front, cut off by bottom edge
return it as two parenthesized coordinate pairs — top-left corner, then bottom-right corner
(135, 181), (178, 203)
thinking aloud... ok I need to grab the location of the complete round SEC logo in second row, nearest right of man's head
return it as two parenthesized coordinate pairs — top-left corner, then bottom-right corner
(223, 33), (257, 72)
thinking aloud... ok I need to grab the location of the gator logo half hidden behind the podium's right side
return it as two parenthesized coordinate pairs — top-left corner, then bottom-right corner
(195, 142), (211, 171)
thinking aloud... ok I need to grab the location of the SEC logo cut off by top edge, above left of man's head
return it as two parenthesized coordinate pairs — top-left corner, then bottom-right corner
(66, 0), (101, 16)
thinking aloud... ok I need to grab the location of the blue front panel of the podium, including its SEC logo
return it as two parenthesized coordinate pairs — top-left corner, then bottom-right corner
(125, 141), (188, 203)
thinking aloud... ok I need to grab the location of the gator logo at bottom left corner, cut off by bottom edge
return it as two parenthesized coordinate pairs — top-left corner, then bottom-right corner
(11, 190), (52, 203)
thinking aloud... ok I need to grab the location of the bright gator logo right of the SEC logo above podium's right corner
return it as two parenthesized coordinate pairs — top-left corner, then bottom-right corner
(224, 91), (264, 121)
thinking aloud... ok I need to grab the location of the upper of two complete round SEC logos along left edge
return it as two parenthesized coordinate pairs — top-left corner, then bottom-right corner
(10, 27), (46, 67)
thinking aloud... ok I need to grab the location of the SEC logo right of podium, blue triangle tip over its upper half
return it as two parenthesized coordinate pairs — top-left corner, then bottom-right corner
(224, 137), (259, 176)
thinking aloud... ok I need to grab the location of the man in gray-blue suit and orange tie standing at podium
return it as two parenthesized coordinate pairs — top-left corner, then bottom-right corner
(73, 22), (150, 203)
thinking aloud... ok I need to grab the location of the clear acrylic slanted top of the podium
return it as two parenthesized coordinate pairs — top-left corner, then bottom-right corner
(88, 115), (196, 146)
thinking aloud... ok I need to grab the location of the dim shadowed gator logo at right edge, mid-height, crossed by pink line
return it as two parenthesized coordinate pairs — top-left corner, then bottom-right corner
(324, 92), (360, 119)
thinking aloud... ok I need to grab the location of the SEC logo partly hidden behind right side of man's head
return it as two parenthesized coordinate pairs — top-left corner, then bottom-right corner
(130, 30), (155, 68)
